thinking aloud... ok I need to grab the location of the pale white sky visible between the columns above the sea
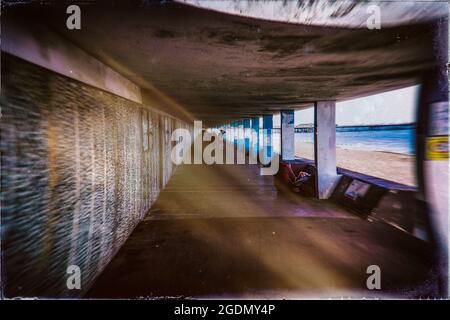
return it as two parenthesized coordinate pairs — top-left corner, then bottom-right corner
(273, 86), (419, 127)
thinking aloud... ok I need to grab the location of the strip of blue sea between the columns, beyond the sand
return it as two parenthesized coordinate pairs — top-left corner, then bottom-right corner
(273, 124), (415, 155)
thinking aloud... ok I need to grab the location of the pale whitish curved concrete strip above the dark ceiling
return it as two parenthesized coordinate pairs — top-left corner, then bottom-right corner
(178, 0), (448, 28)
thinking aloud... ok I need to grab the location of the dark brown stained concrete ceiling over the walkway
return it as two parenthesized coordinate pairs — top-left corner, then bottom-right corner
(2, 1), (442, 124)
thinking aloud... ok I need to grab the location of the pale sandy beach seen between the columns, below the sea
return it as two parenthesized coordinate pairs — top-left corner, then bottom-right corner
(295, 141), (416, 186)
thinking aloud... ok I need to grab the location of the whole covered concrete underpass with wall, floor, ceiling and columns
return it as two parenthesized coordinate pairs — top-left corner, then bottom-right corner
(0, 0), (449, 298)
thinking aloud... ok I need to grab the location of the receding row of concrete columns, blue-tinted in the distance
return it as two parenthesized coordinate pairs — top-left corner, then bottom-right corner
(217, 101), (339, 199)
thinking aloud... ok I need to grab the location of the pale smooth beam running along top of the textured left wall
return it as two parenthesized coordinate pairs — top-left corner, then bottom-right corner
(2, 17), (142, 103)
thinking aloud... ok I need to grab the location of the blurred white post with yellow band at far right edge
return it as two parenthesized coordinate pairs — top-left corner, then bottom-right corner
(416, 19), (450, 297)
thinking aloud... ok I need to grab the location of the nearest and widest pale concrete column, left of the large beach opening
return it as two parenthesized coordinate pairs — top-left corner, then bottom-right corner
(314, 101), (339, 199)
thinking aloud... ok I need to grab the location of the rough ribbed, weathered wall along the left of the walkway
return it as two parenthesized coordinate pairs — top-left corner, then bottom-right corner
(1, 54), (184, 297)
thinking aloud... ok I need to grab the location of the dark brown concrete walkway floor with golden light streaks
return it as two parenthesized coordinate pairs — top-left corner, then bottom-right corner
(87, 165), (433, 298)
